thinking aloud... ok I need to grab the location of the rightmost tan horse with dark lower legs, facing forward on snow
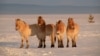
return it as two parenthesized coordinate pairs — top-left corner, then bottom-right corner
(66, 18), (79, 47)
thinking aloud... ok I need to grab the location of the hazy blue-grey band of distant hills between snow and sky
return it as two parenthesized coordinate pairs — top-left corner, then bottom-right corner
(0, 4), (100, 14)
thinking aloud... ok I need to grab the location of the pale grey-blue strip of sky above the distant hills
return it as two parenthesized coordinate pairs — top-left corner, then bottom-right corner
(0, 0), (100, 6)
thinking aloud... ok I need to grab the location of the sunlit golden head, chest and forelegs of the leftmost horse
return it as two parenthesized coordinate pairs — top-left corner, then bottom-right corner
(15, 19), (31, 48)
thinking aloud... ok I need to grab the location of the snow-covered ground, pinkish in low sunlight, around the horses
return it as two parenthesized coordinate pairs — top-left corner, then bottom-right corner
(0, 14), (100, 56)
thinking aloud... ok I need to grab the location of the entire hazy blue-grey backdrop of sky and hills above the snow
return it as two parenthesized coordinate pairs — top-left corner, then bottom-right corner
(0, 0), (100, 14)
